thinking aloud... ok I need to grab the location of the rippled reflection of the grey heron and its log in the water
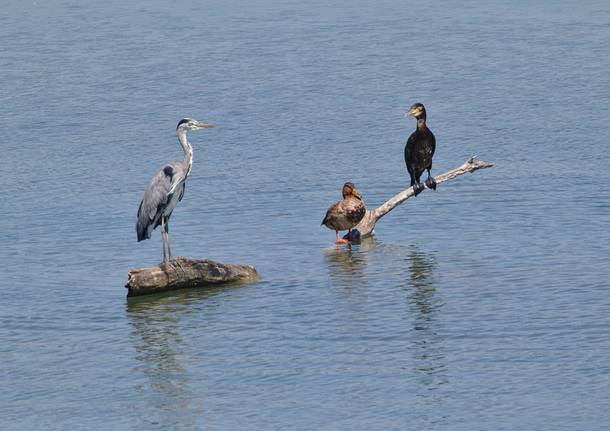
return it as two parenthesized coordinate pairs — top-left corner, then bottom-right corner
(126, 287), (228, 429)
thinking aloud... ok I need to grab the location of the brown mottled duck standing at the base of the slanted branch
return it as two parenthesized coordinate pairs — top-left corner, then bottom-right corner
(322, 181), (366, 244)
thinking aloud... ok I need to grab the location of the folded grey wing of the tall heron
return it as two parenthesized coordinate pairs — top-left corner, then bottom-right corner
(136, 163), (174, 241)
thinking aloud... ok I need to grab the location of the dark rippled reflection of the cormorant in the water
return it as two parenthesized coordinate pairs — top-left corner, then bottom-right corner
(406, 249), (448, 389)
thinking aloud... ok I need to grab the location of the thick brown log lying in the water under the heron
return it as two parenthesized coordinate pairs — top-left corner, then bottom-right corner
(125, 257), (258, 296)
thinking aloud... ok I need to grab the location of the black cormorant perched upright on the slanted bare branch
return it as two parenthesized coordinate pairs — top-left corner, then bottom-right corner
(405, 103), (436, 196)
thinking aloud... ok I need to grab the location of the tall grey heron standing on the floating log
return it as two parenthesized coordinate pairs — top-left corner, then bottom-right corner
(136, 118), (215, 262)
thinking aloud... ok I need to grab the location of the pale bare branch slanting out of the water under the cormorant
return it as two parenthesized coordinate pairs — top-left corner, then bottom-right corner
(344, 156), (493, 241)
